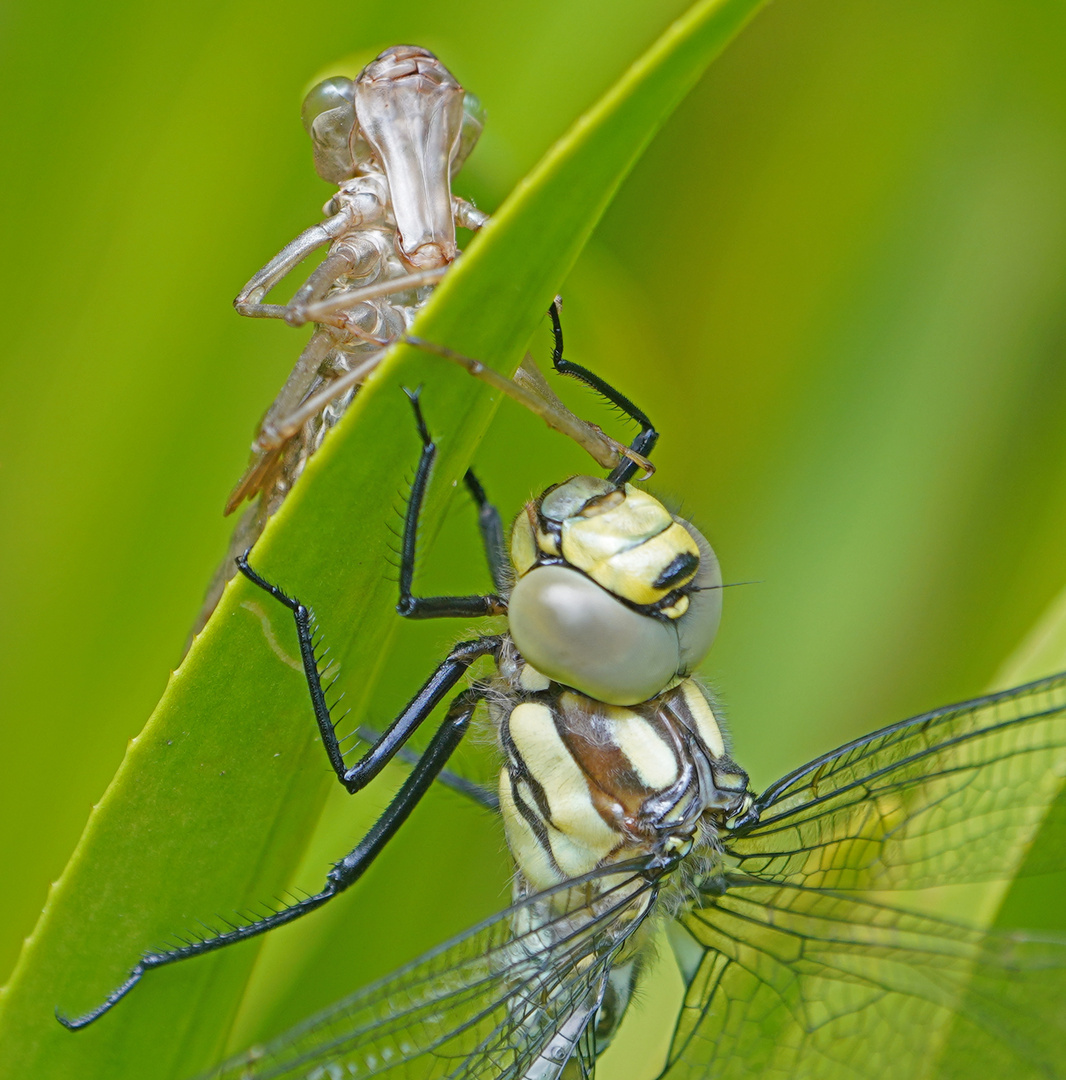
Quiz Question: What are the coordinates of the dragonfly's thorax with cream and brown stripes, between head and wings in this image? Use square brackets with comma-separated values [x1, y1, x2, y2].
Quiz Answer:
[494, 639, 748, 890]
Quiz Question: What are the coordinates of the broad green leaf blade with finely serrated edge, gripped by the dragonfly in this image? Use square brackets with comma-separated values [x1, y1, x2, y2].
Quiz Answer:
[0, 0, 760, 1080]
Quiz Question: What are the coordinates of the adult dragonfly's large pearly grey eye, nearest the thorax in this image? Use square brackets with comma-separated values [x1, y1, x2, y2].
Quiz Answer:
[508, 566, 679, 705]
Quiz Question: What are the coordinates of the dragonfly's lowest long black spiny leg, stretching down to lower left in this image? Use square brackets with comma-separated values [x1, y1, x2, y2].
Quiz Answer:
[56, 686, 485, 1030]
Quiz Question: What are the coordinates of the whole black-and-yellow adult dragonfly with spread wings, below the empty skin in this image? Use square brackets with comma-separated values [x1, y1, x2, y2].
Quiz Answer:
[60, 339, 1066, 1080]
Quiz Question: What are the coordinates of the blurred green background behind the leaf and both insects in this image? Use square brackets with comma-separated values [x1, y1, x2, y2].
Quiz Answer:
[0, 0, 1066, 1071]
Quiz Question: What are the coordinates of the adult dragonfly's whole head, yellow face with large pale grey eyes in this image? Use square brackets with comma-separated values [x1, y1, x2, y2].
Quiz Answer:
[508, 476, 721, 705]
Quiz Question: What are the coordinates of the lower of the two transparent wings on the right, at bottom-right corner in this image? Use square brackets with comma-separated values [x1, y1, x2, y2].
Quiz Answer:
[663, 879, 1066, 1080]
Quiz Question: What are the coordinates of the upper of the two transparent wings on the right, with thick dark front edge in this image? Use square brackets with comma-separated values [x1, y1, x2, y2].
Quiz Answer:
[726, 674, 1066, 890]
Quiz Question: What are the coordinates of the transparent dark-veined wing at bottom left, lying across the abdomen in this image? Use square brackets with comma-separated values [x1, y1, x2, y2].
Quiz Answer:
[197, 867, 656, 1080]
